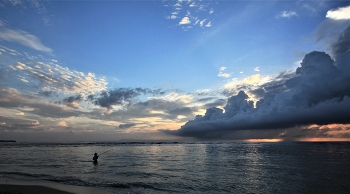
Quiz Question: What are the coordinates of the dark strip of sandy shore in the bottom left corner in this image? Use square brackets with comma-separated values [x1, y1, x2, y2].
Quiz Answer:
[0, 178, 111, 194]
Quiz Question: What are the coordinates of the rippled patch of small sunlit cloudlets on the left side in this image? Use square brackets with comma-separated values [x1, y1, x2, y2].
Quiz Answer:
[2, 55, 107, 97]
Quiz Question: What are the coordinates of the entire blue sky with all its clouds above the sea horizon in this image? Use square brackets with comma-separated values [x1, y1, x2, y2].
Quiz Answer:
[0, 0, 350, 142]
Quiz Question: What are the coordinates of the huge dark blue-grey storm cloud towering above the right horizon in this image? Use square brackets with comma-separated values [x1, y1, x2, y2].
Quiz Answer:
[164, 51, 350, 138]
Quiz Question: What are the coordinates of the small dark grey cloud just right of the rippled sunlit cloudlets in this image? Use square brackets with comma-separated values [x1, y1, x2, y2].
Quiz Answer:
[92, 88, 164, 109]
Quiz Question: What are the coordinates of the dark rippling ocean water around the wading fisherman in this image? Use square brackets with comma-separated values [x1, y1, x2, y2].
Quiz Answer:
[0, 142, 350, 193]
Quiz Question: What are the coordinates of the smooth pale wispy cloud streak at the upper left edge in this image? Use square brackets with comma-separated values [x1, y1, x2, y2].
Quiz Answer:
[0, 28, 52, 53]
